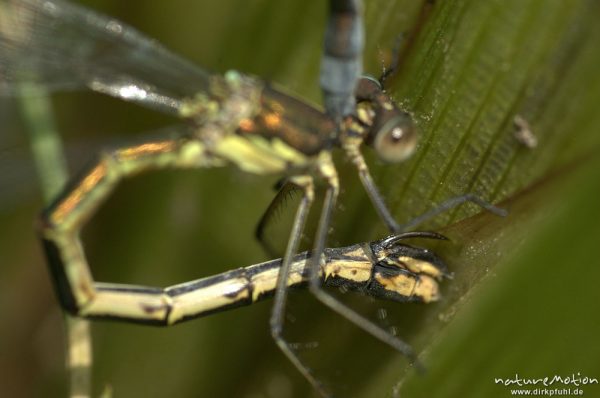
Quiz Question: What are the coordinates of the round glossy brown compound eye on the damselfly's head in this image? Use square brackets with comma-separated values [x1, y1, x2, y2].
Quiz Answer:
[373, 114, 417, 163]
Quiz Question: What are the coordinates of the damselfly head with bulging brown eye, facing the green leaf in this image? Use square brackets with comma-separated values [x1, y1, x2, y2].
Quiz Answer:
[356, 77, 417, 163]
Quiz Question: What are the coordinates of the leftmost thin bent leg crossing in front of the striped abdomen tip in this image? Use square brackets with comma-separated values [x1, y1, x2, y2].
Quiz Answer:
[270, 176, 327, 396]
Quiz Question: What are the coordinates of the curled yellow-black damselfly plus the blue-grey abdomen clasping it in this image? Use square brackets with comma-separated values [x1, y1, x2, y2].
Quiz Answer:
[0, 0, 506, 394]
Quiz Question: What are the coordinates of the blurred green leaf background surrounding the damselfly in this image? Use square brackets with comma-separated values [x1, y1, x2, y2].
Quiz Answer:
[0, 0, 600, 398]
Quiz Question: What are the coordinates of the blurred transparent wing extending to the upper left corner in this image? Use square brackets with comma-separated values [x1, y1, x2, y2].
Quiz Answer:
[0, 0, 209, 114]
